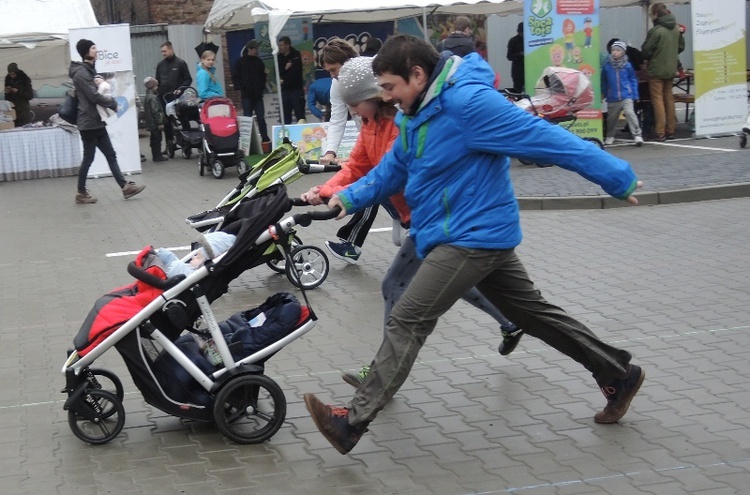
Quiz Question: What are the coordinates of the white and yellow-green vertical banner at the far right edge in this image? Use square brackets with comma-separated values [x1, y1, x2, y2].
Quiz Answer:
[691, 0, 747, 136]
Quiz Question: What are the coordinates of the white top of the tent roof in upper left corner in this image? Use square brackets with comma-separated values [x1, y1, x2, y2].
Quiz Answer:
[0, 0, 99, 46]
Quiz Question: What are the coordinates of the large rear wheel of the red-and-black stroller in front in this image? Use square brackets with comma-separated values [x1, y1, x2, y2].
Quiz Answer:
[214, 375, 286, 444]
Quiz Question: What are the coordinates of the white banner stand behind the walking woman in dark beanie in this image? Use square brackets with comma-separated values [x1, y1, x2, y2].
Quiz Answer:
[69, 24, 141, 177]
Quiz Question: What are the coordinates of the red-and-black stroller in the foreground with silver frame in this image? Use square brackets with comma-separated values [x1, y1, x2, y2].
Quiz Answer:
[62, 184, 338, 444]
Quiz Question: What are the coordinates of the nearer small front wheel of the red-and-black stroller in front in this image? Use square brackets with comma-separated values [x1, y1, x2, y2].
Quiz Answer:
[68, 388, 125, 445]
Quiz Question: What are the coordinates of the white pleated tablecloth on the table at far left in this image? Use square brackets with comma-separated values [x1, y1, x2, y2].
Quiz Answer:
[0, 127, 81, 182]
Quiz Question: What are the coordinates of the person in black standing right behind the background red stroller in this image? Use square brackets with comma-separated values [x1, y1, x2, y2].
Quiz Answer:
[232, 40, 270, 141]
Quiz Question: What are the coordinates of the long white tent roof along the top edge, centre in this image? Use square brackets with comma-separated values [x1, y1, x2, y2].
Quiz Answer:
[205, 0, 664, 33]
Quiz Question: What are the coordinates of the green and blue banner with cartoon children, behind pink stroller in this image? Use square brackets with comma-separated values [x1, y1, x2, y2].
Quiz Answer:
[523, 0, 602, 139]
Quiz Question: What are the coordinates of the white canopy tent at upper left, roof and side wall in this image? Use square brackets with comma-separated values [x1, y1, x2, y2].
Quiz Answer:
[0, 0, 99, 89]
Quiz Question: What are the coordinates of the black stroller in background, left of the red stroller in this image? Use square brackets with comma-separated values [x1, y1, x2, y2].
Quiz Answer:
[164, 87, 203, 158]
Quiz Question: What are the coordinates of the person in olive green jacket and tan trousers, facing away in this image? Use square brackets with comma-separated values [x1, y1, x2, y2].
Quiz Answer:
[641, 3, 685, 141]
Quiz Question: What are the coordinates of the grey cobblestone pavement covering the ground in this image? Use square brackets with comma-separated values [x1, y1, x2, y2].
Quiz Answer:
[0, 138, 750, 495]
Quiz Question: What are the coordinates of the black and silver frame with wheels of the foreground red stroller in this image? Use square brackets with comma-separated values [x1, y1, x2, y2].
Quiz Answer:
[62, 184, 338, 445]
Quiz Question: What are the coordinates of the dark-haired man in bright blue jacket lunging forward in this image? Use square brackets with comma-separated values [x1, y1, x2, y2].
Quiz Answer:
[305, 35, 645, 454]
